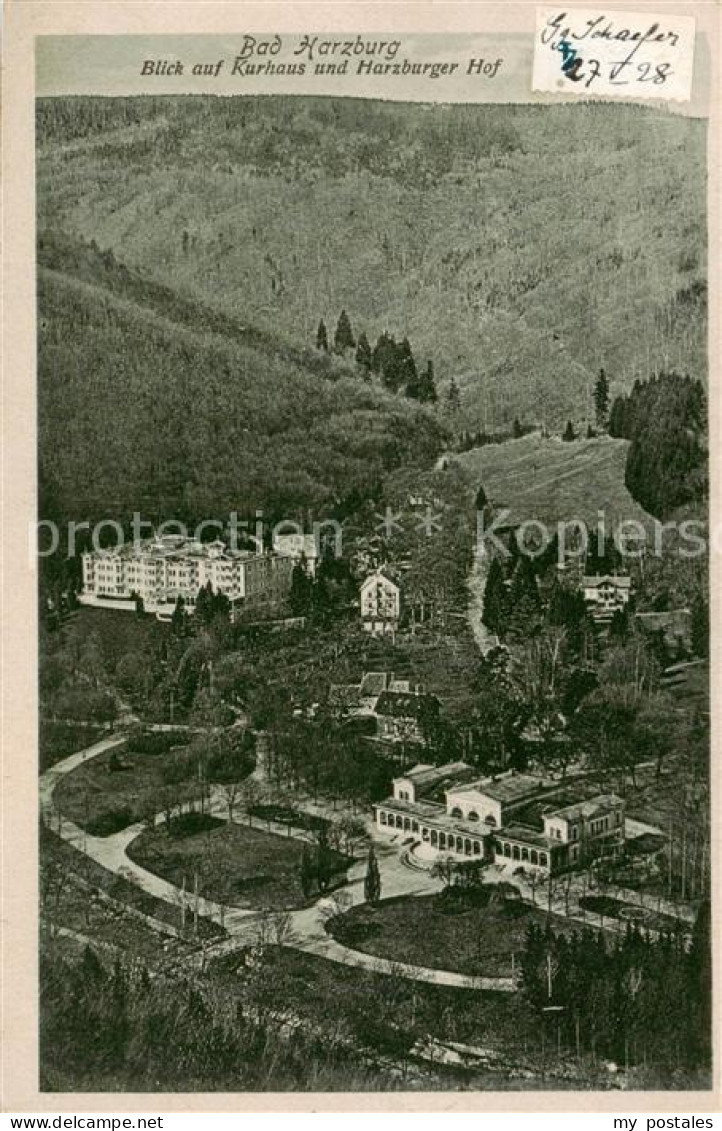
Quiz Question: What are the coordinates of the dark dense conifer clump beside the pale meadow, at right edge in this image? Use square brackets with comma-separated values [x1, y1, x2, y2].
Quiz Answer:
[609, 373, 707, 518]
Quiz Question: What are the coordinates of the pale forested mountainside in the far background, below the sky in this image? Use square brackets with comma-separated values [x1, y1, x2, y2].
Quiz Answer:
[37, 97, 706, 428]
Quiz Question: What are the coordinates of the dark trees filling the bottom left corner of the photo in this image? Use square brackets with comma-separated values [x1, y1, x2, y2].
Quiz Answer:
[41, 948, 390, 1091]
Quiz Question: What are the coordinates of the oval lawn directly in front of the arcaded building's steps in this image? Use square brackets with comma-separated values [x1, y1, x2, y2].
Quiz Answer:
[329, 892, 597, 976]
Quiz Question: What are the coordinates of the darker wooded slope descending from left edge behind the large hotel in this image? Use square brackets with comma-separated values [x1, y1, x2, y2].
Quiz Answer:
[37, 234, 442, 523]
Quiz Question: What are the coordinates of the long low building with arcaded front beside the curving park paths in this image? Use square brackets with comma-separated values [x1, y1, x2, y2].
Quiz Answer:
[375, 762, 625, 874]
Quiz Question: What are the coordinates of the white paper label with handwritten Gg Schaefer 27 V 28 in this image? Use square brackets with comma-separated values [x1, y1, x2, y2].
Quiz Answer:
[532, 7, 695, 102]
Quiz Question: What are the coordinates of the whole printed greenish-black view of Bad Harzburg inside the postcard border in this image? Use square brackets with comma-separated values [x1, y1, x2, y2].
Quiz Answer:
[0, 5, 719, 1096]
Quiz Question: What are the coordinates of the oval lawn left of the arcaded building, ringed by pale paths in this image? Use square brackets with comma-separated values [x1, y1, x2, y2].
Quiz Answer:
[128, 821, 351, 910]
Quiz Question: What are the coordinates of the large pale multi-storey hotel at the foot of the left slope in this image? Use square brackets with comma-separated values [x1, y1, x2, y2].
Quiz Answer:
[84, 535, 294, 616]
